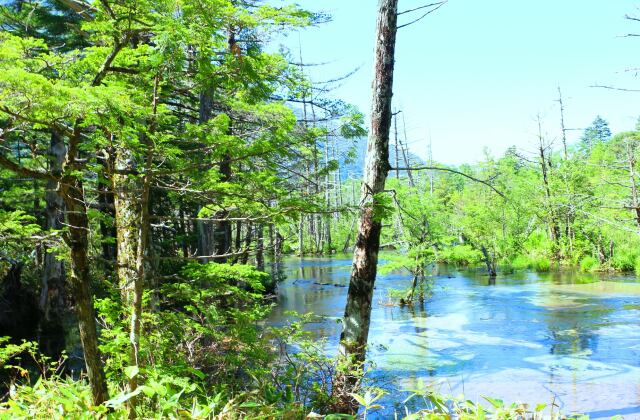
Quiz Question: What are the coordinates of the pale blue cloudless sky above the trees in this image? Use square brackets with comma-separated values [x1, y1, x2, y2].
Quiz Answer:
[271, 0, 640, 165]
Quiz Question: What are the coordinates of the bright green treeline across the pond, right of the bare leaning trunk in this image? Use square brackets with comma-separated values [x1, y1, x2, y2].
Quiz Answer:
[356, 113, 640, 284]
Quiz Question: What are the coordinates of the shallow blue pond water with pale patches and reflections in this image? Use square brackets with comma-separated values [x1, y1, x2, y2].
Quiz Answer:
[269, 257, 640, 419]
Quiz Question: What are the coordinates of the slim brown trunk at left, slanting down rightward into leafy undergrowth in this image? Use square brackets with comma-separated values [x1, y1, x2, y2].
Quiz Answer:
[59, 176, 109, 405]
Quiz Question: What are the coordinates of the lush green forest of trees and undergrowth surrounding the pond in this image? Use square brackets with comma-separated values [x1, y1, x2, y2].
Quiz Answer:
[0, 0, 640, 419]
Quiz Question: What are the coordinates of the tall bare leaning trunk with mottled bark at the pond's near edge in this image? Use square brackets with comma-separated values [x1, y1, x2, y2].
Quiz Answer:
[340, 0, 398, 382]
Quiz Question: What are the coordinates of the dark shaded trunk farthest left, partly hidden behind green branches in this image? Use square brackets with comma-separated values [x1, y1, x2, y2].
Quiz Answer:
[39, 133, 67, 358]
